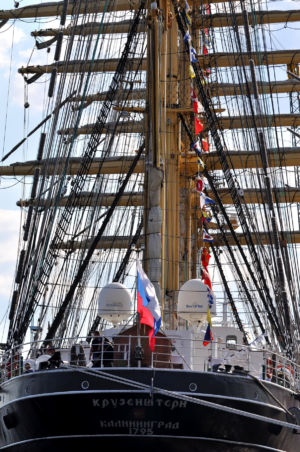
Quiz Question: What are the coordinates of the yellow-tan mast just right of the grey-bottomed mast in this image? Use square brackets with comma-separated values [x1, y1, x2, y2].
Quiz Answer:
[161, 1, 180, 328]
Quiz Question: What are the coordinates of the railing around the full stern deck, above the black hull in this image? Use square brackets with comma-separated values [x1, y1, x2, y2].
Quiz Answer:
[1, 334, 300, 390]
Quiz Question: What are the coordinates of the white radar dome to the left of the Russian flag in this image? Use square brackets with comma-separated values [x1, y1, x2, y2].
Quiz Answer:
[98, 283, 132, 325]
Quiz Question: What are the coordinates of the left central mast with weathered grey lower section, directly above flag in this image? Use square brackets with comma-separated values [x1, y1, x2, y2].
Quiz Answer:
[144, 2, 163, 308]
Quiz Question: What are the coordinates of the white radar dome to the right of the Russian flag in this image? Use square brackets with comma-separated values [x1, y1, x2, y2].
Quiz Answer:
[177, 279, 216, 323]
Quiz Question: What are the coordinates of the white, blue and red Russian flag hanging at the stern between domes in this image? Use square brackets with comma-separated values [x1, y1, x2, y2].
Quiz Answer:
[137, 261, 161, 352]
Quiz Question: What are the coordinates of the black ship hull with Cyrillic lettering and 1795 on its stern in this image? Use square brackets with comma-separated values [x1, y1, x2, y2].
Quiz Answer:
[0, 369, 300, 452]
